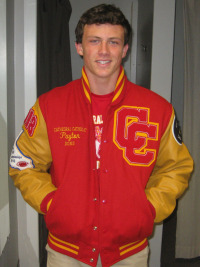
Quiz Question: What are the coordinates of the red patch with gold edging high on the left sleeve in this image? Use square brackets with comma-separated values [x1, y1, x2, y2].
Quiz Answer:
[24, 108, 38, 137]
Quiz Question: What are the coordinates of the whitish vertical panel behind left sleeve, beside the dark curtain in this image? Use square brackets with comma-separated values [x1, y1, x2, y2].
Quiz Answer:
[14, 0, 39, 267]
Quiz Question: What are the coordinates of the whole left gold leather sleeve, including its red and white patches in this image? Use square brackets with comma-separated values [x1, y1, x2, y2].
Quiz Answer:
[9, 100, 56, 213]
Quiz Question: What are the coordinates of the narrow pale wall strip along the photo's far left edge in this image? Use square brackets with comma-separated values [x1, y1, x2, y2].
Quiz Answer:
[0, 0, 10, 255]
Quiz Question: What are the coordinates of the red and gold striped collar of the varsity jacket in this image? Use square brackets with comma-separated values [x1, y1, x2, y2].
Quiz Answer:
[81, 66, 127, 104]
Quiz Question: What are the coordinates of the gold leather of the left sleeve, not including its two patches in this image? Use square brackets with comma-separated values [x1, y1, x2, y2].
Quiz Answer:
[9, 100, 56, 213]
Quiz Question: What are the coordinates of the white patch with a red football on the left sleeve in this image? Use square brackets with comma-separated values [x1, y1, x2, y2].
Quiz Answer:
[10, 131, 35, 171]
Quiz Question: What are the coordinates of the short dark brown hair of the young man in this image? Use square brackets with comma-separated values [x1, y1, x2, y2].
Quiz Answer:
[75, 4, 132, 45]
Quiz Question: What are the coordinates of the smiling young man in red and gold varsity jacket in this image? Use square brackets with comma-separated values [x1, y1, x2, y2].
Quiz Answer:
[10, 4, 193, 267]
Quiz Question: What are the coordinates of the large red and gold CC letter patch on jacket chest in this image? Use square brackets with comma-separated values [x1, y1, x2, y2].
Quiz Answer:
[113, 106, 159, 167]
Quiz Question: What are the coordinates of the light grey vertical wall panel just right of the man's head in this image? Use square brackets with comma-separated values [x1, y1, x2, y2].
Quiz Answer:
[150, 0, 175, 267]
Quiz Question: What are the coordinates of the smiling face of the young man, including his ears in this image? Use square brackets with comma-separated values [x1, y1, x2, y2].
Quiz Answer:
[76, 24, 128, 80]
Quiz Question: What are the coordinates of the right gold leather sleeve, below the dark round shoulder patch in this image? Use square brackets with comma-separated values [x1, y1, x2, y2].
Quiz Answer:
[146, 109, 193, 223]
